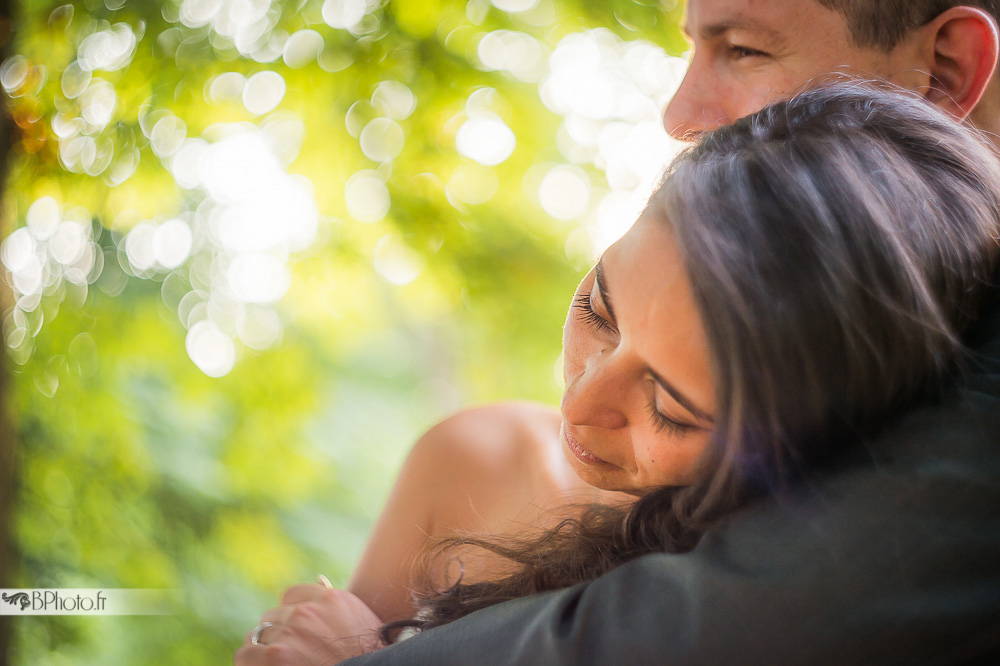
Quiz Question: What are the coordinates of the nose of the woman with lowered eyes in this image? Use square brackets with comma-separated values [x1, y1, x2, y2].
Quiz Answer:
[561, 352, 628, 430]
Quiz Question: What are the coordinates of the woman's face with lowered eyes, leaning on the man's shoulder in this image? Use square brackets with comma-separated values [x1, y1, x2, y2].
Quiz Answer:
[562, 214, 715, 495]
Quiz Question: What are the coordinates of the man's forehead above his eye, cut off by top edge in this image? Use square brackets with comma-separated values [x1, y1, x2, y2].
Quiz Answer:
[683, 0, 843, 39]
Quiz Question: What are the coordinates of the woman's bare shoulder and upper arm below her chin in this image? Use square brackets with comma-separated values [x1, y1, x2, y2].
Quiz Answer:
[347, 403, 561, 622]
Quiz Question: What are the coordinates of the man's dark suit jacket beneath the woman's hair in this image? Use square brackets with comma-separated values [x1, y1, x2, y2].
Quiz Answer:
[349, 302, 1000, 666]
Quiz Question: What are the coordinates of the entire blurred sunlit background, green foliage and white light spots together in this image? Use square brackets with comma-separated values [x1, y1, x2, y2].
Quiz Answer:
[0, 0, 686, 664]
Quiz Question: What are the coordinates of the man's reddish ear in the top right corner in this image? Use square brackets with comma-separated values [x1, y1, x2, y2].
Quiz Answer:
[922, 7, 1000, 120]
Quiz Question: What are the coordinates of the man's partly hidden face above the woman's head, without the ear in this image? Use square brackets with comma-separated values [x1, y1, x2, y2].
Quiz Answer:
[663, 0, 907, 138]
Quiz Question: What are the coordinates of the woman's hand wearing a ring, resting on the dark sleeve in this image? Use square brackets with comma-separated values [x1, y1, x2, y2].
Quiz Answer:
[233, 576, 382, 666]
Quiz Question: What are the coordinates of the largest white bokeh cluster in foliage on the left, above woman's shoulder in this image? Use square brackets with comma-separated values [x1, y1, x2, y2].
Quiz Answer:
[116, 118, 319, 377]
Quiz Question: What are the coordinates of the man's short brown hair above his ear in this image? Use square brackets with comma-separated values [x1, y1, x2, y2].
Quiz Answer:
[818, 0, 1000, 51]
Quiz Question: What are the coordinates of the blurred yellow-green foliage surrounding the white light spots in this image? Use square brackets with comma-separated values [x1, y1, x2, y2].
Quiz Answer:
[2, 0, 685, 664]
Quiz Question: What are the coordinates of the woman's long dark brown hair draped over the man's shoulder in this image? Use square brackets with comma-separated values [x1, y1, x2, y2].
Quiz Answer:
[383, 83, 1000, 641]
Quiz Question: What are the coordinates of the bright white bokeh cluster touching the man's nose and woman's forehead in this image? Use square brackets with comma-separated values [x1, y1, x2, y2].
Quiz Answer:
[538, 28, 687, 254]
